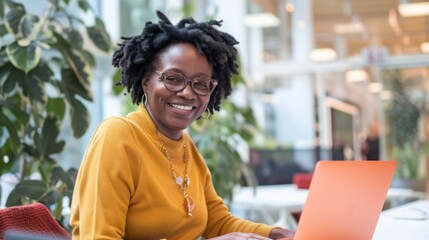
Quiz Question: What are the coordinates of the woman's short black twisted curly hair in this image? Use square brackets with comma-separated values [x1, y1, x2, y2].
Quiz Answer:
[112, 11, 238, 114]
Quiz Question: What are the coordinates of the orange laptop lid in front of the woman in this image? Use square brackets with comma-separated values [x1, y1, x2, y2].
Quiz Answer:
[294, 160, 396, 240]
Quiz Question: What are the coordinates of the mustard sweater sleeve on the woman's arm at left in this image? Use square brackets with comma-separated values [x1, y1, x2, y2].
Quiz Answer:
[70, 118, 141, 239]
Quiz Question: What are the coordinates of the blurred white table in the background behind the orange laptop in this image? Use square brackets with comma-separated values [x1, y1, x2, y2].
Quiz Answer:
[231, 184, 429, 230]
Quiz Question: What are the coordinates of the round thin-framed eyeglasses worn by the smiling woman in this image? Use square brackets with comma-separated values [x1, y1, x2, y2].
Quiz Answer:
[153, 70, 218, 96]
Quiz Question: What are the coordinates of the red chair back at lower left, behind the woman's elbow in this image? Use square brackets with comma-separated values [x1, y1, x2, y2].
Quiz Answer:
[0, 203, 71, 240]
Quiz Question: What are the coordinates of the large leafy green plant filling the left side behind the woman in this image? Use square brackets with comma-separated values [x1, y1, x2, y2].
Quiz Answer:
[0, 0, 112, 226]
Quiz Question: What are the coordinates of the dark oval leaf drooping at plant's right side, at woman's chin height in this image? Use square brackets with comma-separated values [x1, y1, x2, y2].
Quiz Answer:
[70, 99, 90, 138]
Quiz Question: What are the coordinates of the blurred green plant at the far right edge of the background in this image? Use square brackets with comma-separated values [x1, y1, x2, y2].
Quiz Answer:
[387, 70, 429, 191]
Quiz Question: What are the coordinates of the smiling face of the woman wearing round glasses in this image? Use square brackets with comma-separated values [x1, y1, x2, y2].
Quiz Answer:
[142, 43, 214, 140]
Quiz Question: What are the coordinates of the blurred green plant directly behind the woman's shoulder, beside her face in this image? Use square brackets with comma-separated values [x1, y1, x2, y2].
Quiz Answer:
[189, 59, 259, 202]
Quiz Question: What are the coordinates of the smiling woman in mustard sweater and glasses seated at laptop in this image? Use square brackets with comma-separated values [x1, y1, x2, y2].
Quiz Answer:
[70, 12, 294, 239]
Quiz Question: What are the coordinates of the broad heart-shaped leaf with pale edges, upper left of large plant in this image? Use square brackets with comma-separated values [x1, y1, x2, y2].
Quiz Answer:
[6, 41, 42, 73]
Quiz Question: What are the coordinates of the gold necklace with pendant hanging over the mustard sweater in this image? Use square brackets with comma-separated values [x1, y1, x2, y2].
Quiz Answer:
[156, 130, 195, 217]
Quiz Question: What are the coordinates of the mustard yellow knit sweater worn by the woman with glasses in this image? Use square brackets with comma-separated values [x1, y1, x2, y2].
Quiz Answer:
[70, 107, 273, 240]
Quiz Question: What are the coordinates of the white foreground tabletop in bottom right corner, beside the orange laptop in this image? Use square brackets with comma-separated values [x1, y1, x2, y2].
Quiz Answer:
[373, 200, 429, 240]
